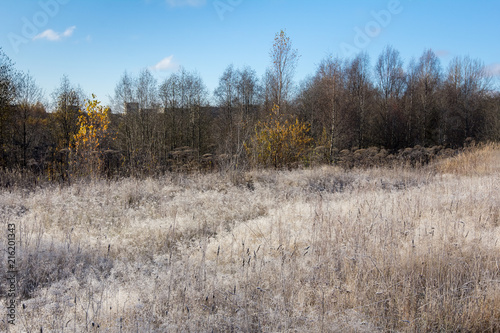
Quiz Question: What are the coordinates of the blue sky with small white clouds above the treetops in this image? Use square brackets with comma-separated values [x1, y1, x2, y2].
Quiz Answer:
[0, 0, 500, 103]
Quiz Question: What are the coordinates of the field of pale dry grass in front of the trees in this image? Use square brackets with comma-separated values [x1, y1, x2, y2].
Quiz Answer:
[0, 145, 500, 332]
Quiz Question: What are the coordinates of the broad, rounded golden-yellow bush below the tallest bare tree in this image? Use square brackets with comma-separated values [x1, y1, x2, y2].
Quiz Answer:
[245, 105, 313, 168]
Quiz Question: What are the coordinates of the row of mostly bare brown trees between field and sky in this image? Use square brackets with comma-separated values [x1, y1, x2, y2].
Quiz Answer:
[0, 31, 500, 181]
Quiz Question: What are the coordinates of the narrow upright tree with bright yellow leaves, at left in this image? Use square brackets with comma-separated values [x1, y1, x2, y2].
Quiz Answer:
[70, 94, 110, 177]
